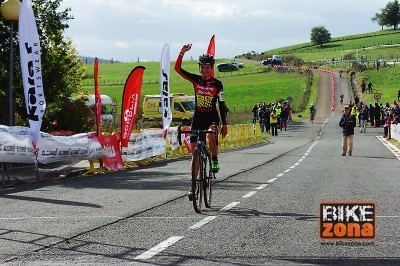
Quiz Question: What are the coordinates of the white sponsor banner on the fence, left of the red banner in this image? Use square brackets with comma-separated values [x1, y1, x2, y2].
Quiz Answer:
[0, 125, 105, 164]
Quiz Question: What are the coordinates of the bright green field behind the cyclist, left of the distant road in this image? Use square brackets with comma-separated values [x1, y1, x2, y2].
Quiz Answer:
[79, 60, 306, 121]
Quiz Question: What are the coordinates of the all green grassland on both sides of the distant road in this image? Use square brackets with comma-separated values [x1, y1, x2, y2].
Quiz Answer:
[77, 30, 400, 125]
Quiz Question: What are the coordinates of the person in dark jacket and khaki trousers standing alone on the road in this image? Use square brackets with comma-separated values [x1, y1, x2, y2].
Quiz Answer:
[339, 106, 357, 156]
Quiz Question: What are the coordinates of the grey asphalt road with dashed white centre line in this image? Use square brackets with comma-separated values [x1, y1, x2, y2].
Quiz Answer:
[0, 71, 400, 265]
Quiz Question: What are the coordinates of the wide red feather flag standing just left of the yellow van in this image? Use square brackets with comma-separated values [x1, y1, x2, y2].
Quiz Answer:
[121, 66, 146, 147]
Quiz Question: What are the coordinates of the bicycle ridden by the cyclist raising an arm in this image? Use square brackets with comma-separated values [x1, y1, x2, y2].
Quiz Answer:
[178, 126, 218, 213]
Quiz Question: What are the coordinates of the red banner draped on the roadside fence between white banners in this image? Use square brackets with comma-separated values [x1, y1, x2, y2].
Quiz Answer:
[99, 135, 124, 171]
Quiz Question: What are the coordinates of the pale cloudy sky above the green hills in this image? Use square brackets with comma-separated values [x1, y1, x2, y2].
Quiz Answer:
[60, 0, 389, 62]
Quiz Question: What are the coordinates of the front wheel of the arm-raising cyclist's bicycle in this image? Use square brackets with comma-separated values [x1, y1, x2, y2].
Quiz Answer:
[192, 148, 204, 213]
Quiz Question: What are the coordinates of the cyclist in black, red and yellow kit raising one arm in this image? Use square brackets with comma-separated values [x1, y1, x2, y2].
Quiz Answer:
[175, 44, 228, 198]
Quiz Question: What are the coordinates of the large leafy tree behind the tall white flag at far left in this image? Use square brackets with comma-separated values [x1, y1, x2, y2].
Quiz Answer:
[0, 0, 85, 128]
